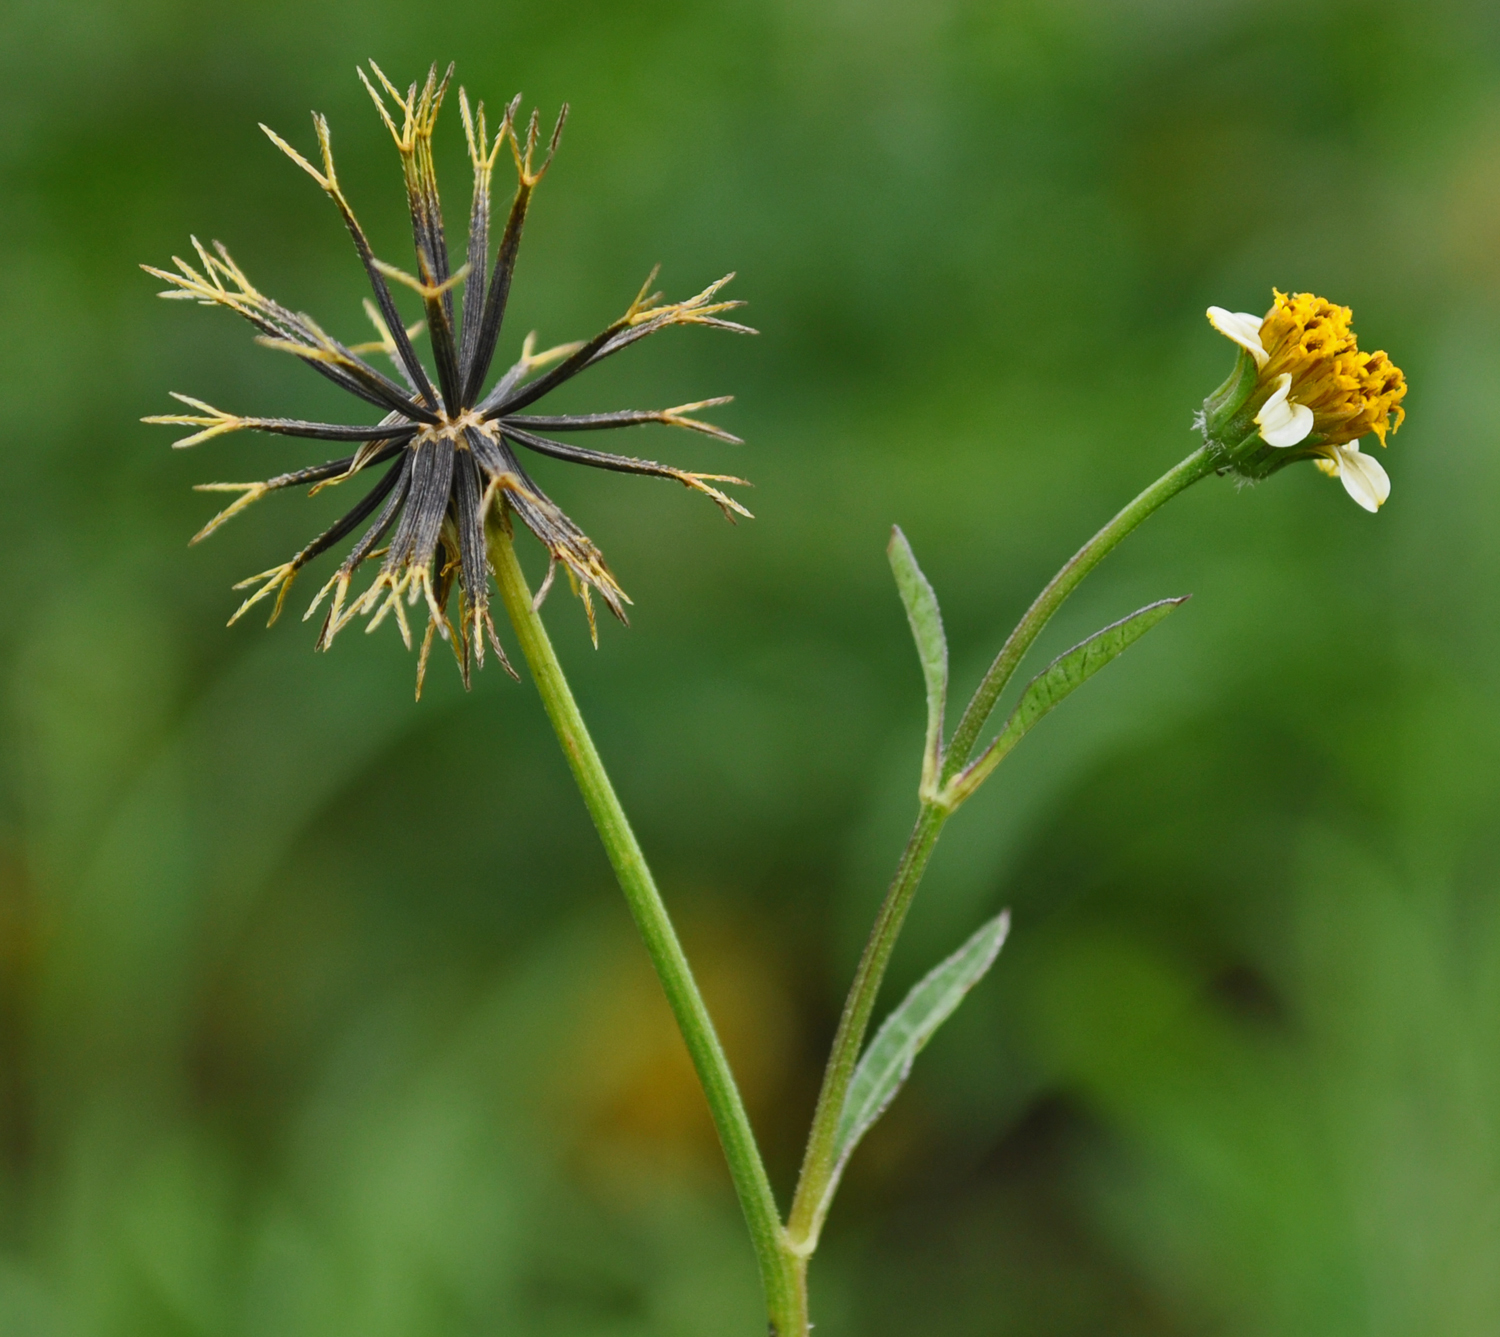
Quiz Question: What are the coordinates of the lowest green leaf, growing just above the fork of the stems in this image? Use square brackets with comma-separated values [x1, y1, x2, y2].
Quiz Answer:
[819, 911, 1011, 1220]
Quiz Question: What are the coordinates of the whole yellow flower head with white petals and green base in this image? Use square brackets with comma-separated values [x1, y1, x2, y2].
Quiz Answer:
[1202, 293, 1407, 510]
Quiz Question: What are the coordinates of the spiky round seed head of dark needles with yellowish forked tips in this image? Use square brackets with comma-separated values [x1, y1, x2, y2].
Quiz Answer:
[143, 62, 753, 696]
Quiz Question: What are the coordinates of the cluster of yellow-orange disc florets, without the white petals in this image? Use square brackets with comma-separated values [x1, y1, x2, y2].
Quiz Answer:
[1260, 290, 1406, 446]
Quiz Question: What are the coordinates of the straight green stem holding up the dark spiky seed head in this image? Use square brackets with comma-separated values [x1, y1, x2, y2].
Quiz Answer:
[489, 521, 807, 1337]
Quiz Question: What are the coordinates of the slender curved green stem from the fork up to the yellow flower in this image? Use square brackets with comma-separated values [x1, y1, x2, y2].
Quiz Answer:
[786, 447, 1214, 1257]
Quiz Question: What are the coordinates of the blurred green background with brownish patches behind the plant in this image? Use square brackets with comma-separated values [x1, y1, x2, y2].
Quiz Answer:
[0, 0, 1500, 1337]
